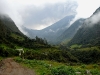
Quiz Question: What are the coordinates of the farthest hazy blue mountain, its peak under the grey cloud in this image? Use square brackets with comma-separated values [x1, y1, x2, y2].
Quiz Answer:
[24, 15, 75, 44]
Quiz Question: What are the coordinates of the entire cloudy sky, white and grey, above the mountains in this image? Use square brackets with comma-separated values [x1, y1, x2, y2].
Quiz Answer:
[0, 0, 100, 29]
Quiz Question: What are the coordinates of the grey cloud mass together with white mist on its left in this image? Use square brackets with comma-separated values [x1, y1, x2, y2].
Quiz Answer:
[0, 0, 78, 31]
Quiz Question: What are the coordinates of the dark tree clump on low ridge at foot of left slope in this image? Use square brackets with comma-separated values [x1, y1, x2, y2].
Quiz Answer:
[22, 37, 51, 49]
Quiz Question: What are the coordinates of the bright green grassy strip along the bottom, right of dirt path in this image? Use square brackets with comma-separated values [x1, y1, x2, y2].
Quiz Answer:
[15, 57, 100, 75]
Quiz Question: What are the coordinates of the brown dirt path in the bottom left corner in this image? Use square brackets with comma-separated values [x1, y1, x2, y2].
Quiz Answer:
[0, 58, 35, 75]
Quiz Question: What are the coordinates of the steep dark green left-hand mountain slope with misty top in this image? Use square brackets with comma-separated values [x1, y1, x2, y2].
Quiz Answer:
[0, 14, 25, 46]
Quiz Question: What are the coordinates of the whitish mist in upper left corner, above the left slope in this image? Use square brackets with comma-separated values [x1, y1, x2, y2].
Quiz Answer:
[0, 0, 23, 30]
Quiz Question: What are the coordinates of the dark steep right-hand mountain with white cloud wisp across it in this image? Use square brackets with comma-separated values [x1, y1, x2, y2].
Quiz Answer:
[68, 7, 100, 46]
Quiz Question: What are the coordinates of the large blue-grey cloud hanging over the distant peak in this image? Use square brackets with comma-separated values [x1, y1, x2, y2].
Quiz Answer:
[20, 2, 77, 29]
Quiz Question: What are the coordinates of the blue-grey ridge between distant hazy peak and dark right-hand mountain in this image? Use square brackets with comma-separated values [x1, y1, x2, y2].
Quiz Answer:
[58, 18, 85, 42]
